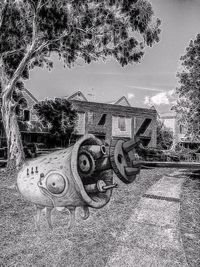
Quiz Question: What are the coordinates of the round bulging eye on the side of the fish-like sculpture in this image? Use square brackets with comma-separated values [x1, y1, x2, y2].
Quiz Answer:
[46, 173, 66, 194]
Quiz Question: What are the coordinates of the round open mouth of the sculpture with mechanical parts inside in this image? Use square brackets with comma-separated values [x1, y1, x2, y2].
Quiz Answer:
[71, 134, 113, 208]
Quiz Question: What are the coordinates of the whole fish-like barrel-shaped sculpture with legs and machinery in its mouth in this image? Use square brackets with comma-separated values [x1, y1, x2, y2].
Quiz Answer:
[17, 135, 140, 228]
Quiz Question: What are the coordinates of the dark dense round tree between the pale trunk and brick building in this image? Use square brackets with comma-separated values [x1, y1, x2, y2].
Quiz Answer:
[34, 98, 78, 146]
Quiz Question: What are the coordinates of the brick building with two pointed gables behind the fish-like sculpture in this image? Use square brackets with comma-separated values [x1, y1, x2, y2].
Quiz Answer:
[65, 91, 157, 146]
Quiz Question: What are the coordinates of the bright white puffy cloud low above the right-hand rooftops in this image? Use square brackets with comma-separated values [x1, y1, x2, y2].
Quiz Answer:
[144, 90, 174, 106]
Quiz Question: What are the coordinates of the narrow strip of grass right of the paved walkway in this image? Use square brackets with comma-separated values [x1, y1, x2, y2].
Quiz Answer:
[180, 176, 200, 267]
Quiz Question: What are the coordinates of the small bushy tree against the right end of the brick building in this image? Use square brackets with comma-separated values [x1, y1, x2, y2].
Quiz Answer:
[157, 120, 173, 149]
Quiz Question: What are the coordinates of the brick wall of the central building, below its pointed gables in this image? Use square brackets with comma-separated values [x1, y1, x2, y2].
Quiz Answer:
[71, 100, 157, 146]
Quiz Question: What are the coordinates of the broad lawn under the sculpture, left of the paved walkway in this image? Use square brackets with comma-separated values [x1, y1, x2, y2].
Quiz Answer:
[0, 169, 178, 267]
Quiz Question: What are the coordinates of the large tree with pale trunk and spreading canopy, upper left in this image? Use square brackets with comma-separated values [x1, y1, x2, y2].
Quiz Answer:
[0, 0, 160, 170]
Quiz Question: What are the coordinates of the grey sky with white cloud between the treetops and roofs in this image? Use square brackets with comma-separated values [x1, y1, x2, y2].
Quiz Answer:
[26, 0, 200, 112]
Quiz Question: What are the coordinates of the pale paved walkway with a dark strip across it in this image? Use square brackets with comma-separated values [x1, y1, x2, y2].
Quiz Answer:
[107, 172, 188, 267]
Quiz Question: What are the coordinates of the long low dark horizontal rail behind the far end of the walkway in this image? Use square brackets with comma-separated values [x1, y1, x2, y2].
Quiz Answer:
[133, 161, 200, 170]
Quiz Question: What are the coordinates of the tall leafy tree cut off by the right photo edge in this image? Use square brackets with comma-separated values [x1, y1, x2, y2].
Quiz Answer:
[173, 34, 200, 141]
